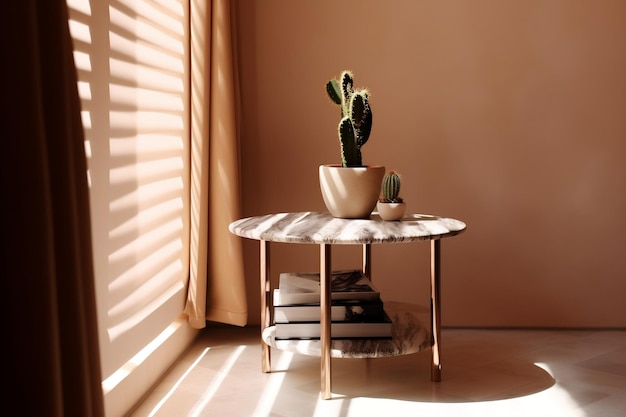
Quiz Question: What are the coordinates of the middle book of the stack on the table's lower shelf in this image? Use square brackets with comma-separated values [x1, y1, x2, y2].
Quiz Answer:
[273, 289, 384, 323]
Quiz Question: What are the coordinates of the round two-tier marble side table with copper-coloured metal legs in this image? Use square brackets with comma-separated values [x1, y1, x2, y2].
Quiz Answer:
[229, 212, 466, 399]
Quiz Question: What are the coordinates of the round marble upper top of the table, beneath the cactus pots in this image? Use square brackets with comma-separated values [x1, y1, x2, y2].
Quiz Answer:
[229, 211, 466, 244]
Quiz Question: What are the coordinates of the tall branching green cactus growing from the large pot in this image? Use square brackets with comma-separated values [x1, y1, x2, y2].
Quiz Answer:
[326, 70, 372, 167]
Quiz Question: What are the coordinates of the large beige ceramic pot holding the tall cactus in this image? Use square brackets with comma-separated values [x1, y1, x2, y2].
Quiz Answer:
[319, 165, 385, 219]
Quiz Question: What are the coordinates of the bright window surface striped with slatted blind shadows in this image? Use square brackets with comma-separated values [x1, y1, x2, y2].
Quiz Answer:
[68, 0, 189, 386]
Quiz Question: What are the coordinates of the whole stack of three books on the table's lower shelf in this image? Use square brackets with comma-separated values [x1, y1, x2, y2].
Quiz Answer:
[273, 270, 392, 339]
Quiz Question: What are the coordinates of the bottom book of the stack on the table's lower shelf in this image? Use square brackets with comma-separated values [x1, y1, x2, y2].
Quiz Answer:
[274, 312, 393, 340]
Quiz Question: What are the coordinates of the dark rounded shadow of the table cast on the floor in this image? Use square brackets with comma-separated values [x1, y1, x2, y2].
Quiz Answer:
[280, 330, 555, 403]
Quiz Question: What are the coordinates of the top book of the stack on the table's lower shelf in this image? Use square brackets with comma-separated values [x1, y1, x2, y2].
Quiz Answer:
[278, 269, 380, 304]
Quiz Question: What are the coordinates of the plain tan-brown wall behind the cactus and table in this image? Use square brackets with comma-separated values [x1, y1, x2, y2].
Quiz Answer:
[238, 0, 626, 327]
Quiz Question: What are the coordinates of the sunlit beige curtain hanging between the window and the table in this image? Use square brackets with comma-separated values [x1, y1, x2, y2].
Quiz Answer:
[185, 0, 248, 328]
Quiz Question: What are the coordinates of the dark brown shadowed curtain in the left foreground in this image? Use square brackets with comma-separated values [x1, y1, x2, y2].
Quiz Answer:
[0, 0, 104, 417]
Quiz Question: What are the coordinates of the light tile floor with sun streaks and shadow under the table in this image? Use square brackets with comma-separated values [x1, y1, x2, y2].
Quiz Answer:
[130, 326, 626, 417]
